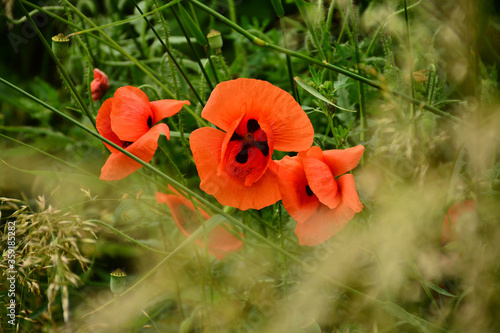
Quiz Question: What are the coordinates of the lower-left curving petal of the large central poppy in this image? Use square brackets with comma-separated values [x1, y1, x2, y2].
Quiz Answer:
[189, 127, 281, 210]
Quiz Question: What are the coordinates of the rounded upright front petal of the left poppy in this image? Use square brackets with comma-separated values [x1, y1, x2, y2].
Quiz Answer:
[111, 86, 153, 142]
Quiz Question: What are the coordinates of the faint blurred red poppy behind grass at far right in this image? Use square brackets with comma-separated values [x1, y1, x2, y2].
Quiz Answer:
[441, 200, 476, 245]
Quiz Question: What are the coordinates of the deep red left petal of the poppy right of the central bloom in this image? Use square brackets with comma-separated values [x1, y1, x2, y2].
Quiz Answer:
[278, 156, 321, 224]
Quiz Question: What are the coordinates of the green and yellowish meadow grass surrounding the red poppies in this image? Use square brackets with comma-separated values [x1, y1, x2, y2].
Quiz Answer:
[0, 0, 500, 332]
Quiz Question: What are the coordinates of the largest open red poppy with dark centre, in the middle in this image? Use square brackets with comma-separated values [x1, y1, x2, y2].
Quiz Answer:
[189, 79, 314, 210]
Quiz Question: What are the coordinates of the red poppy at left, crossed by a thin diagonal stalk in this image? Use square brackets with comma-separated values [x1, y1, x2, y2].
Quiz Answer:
[96, 86, 189, 180]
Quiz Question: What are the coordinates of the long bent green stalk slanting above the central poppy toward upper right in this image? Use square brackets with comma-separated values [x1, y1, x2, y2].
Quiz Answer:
[188, 0, 460, 122]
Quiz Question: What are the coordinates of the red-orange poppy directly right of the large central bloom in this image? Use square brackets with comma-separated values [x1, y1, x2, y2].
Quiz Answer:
[278, 145, 364, 246]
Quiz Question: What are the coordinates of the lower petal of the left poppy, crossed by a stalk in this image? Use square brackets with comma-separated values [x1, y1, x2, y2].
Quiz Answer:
[100, 123, 170, 180]
